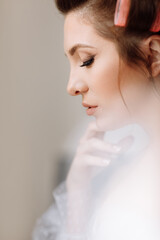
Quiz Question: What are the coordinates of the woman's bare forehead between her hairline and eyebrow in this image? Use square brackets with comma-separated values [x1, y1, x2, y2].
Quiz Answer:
[64, 12, 101, 52]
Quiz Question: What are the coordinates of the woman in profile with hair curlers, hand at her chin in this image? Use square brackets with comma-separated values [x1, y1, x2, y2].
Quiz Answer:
[33, 0, 160, 240]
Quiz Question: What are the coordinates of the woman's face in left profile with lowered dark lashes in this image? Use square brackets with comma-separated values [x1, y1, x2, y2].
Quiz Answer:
[64, 12, 151, 131]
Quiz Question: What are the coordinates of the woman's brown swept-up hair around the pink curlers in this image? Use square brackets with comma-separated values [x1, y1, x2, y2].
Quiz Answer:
[55, 0, 160, 71]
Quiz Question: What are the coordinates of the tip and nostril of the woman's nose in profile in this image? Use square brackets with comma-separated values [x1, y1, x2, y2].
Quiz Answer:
[67, 73, 88, 96]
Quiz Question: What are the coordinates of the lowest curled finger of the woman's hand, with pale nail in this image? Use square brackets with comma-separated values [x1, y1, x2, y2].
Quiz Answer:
[84, 155, 111, 167]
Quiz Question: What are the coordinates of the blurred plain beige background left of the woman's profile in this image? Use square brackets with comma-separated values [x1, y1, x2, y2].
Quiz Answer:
[0, 0, 90, 240]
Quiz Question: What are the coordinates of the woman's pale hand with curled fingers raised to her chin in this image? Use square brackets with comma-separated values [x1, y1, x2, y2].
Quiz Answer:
[67, 122, 133, 190]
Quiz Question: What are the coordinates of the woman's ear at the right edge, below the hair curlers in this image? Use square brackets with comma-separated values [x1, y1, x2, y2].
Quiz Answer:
[146, 35, 160, 77]
